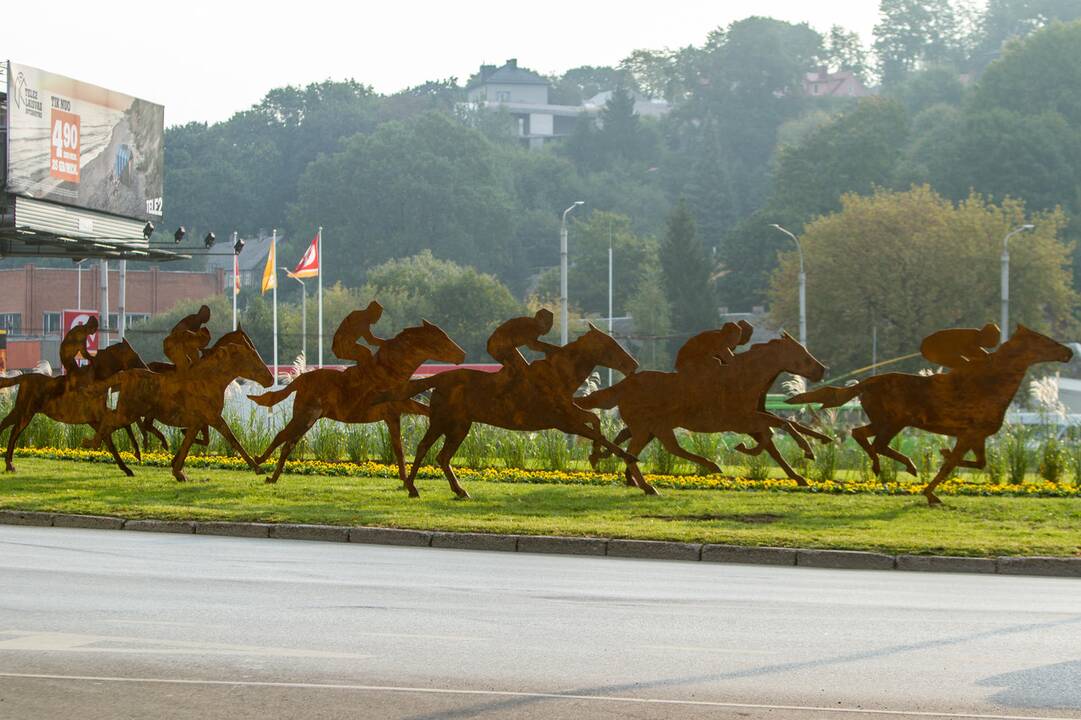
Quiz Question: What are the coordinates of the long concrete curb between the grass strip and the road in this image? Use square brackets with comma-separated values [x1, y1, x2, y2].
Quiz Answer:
[0, 510, 1081, 577]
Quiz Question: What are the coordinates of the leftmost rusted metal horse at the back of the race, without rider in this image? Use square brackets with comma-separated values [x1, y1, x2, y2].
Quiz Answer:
[0, 341, 146, 475]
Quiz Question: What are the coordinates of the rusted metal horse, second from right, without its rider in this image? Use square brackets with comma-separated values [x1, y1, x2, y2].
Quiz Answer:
[575, 333, 828, 485]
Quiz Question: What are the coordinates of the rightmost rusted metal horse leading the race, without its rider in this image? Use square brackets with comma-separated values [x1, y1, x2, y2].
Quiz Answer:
[786, 325, 1073, 505]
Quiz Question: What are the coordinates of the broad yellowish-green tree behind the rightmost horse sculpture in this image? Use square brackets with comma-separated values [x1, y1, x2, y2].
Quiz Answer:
[770, 186, 1077, 372]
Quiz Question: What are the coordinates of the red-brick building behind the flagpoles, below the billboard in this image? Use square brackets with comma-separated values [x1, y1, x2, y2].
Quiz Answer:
[0, 261, 225, 368]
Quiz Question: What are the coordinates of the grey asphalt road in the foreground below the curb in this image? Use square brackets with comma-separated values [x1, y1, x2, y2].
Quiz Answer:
[0, 525, 1081, 720]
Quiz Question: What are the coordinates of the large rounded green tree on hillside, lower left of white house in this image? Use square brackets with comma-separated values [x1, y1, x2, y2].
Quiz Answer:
[290, 112, 520, 285]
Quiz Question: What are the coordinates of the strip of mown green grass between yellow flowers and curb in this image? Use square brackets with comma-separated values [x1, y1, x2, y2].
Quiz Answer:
[0, 457, 1081, 556]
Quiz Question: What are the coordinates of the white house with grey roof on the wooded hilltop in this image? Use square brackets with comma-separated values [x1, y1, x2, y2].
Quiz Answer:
[466, 57, 668, 148]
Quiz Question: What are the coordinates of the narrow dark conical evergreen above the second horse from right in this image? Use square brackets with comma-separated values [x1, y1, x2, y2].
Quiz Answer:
[660, 200, 718, 339]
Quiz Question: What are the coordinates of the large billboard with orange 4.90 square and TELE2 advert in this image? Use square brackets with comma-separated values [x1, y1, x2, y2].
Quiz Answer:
[6, 63, 165, 221]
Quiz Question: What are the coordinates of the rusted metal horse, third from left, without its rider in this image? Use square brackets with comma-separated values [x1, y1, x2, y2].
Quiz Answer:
[250, 320, 465, 482]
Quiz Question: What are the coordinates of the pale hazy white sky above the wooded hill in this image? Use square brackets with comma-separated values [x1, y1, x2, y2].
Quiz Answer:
[0, 0, 879, 125]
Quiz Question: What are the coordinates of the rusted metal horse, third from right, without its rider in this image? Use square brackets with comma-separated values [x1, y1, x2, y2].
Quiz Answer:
[393, 324, 639, 497]
